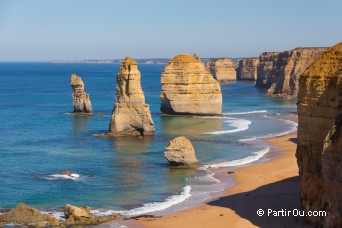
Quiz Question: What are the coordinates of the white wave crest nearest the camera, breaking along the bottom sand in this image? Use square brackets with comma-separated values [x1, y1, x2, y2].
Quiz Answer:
[91, 186, 191, 216]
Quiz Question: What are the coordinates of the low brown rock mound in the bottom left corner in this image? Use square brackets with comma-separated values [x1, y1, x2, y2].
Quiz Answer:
[0, 203, 59, 227]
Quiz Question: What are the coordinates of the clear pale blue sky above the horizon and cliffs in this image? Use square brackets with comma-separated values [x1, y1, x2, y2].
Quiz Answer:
[0, 0, 342, 61]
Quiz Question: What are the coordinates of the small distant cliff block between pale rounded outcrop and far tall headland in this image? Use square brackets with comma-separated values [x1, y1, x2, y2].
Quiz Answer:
[236, 58, 259, 81]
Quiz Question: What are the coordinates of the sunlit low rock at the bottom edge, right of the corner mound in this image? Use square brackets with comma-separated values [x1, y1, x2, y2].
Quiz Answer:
[64, 204, 118, 226]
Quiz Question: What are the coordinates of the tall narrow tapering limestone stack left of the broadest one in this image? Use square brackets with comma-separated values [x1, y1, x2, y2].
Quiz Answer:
[109, 57, 154, 136]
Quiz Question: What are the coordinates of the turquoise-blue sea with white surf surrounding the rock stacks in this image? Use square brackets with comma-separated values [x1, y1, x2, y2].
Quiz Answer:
[0, 63, 296, 215]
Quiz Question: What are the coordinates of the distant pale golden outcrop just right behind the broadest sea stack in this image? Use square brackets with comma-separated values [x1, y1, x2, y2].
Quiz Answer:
[205, 58, 236, 81]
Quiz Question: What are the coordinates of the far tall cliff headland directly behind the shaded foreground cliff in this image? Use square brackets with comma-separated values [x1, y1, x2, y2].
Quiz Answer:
[267, 48, 326, 96]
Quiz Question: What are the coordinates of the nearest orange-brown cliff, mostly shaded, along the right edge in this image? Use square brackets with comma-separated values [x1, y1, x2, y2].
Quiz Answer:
[296, 43, 342, 227]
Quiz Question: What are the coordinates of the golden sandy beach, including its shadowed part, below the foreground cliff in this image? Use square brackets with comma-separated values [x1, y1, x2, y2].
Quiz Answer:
[130, 125, 308, 228]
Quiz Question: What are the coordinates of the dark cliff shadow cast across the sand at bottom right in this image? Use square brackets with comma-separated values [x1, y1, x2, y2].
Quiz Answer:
[208, 177, 311, 228]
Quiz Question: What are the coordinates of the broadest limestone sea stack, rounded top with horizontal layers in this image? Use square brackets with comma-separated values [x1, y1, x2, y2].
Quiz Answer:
[160, 54, 222, 115]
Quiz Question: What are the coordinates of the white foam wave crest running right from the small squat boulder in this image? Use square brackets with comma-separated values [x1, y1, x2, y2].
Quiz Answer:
[204, 147, 270, 168]
